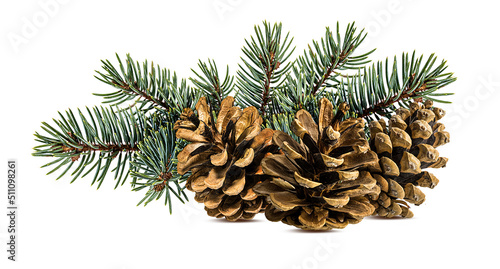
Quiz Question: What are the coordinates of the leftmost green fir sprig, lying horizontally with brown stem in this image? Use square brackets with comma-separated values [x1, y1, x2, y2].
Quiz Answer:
[33, 107, 152, 188]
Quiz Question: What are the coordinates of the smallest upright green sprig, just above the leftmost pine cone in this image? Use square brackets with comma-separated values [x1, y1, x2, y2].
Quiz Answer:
[190, 59, 234, 113]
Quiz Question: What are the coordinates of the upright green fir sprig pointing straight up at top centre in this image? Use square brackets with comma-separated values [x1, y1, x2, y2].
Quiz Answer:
[235, 22, 295, 117]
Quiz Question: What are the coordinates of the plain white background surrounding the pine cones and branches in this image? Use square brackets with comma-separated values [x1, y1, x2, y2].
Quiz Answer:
[0, 0, 500, 269]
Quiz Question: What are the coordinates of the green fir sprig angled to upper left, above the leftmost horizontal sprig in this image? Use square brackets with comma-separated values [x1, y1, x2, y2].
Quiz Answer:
[95, 54, 199, 115]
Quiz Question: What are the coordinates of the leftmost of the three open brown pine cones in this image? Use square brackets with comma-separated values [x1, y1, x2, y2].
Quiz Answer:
[174, 97, 277, 221]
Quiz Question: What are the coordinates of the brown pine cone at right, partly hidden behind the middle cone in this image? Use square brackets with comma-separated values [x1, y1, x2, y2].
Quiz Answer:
[369, 100, 450, 218]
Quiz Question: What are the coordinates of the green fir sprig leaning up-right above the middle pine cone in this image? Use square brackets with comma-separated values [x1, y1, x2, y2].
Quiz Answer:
[270, 23, 374, 124]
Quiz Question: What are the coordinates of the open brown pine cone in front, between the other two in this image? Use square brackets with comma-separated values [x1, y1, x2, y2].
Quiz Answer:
[254, 98, 380, 230]
